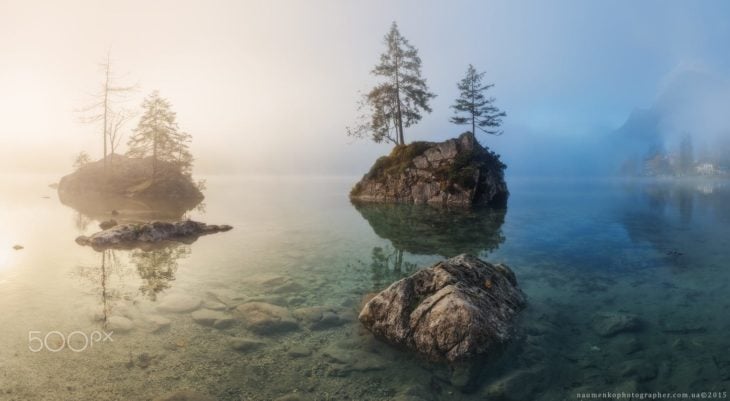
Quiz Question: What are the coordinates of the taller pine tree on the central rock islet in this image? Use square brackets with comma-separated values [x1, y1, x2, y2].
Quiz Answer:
[348, 22, 436, 145]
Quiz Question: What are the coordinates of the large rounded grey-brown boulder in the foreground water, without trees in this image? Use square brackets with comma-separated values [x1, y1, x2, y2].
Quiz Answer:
[359, 254, 526, 362]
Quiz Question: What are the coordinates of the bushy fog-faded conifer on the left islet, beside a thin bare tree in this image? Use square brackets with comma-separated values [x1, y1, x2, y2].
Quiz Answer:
[127, 91, 193, 178]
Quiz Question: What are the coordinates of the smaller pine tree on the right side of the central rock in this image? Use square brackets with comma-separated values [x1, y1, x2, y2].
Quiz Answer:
[450, 64, 507, 135]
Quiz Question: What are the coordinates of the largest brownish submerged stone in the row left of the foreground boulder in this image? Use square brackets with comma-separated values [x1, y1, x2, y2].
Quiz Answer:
[235, 302, 299, 335]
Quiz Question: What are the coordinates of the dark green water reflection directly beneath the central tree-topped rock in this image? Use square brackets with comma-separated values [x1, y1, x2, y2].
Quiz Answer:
[354, 203, 506, 288]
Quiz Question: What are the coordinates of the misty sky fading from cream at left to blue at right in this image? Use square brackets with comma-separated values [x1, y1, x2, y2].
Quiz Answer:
[0, 0, 730, 175]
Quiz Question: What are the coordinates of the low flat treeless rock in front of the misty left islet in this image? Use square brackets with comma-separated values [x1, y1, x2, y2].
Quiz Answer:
[76, 220, 232, 249]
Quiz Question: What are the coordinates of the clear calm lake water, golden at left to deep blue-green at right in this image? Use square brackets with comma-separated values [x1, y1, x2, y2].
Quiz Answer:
[0, 176, 730, 400]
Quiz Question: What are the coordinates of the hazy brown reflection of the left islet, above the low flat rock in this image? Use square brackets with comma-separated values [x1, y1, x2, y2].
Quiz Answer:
[58, 188, 205, 222]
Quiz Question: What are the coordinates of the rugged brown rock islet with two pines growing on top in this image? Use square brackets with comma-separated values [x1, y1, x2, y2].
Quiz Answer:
[350, 132, 509, 207]
